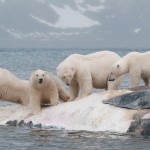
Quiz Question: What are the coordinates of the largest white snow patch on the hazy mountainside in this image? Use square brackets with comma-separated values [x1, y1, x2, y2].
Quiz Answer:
[30, 5, 100, 29]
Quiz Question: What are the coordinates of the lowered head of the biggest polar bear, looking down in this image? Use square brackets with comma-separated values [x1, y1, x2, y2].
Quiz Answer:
[57, 63, 75, 86]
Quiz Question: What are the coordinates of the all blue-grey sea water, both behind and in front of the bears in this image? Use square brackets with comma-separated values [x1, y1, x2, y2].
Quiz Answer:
[0, 49, 150, 150]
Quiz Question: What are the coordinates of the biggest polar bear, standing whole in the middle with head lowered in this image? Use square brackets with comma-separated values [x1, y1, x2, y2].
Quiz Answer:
[57, 51, 122, 100]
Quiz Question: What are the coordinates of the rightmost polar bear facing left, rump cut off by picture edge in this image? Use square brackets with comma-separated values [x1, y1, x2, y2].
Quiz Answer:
[109, 51, 150, 88]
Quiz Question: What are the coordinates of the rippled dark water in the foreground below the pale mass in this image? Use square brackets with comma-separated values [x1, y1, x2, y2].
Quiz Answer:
[0, 127, 150, 150]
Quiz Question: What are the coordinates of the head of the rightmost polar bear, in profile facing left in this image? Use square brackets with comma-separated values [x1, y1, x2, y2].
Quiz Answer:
[109, 60, 128, 81]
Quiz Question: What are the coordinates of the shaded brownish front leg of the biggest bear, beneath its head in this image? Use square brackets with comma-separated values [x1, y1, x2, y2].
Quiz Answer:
[69, 82, 79, 101]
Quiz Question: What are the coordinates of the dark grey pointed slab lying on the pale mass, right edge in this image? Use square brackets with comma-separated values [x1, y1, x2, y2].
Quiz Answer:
[103, 89, 150, 109]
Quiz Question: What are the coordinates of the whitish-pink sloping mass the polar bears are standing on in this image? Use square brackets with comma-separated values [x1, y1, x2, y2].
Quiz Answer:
[0, 90, 137, 133]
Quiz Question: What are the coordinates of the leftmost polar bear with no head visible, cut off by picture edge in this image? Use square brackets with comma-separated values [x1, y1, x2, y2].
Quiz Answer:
[0, 68, 29, 106]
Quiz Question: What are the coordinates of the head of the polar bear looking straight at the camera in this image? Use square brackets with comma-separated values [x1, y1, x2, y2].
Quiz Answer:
[30, 69, 49, 88]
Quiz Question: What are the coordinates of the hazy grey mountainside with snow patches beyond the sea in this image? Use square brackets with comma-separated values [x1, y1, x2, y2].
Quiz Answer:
[0, 0, 150, 48]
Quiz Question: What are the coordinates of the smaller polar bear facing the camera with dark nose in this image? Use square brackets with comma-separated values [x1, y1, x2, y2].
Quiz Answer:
[29, 69, 70, 114]
